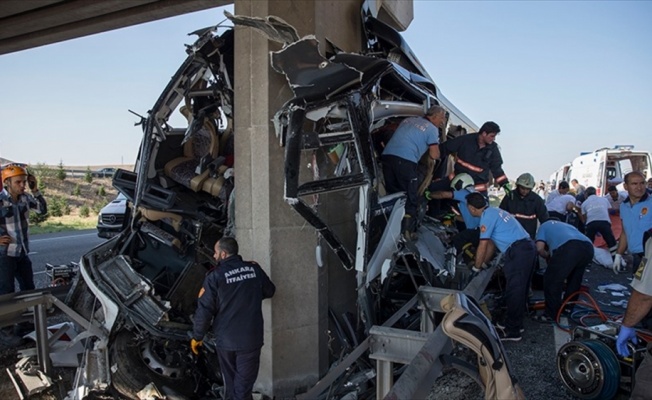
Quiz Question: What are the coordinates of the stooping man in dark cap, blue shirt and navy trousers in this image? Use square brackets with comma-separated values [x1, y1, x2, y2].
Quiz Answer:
[466, 193, 537, 342]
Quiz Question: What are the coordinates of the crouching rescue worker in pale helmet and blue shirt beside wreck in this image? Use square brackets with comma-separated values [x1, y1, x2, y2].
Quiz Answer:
[426, 173, 480, 262]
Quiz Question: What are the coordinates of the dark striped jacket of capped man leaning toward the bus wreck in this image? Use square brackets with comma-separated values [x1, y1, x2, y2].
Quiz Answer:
[439, 133, 508, 186]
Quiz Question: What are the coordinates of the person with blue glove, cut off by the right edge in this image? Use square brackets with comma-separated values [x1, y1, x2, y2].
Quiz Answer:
[616, 230, 652, 400]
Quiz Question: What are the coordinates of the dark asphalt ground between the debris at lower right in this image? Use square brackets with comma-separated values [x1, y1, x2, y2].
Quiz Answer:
[429, 264, 631, 400]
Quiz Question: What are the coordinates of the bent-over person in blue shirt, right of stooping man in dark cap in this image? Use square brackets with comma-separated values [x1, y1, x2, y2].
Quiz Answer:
[536, 220, 594, 322]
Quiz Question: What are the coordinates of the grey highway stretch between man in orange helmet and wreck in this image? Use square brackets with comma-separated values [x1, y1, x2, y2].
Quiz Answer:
[29, 229, 106, 288]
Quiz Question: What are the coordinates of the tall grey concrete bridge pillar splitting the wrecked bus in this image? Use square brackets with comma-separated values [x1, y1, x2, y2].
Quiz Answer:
[235, 0, 410, 398]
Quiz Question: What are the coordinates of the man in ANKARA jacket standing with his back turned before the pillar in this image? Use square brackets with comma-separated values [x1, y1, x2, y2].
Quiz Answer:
[190, 237, 276, 400]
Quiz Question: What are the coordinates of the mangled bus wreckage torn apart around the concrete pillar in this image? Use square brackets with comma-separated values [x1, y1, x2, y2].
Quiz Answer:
[3, 6, 522, 399]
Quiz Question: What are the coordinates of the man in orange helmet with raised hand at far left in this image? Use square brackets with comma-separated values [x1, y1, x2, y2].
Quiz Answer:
[0, 165, 48, 346]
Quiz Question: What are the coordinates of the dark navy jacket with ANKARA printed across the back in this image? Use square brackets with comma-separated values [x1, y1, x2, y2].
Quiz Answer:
[193, 255, 276, 351]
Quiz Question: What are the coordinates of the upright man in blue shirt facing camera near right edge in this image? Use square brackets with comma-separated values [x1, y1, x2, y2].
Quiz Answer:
[613, 171, 652, 273]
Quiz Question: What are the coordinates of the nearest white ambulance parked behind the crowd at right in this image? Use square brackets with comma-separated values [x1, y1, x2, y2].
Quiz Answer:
[566, 145, 652, 196]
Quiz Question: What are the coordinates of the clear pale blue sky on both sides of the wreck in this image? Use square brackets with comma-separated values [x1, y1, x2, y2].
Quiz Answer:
[0, 0, 652, 181]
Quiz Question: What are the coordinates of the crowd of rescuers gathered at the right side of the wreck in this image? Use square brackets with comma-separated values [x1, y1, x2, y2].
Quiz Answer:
[382, 106, 652, 398]
